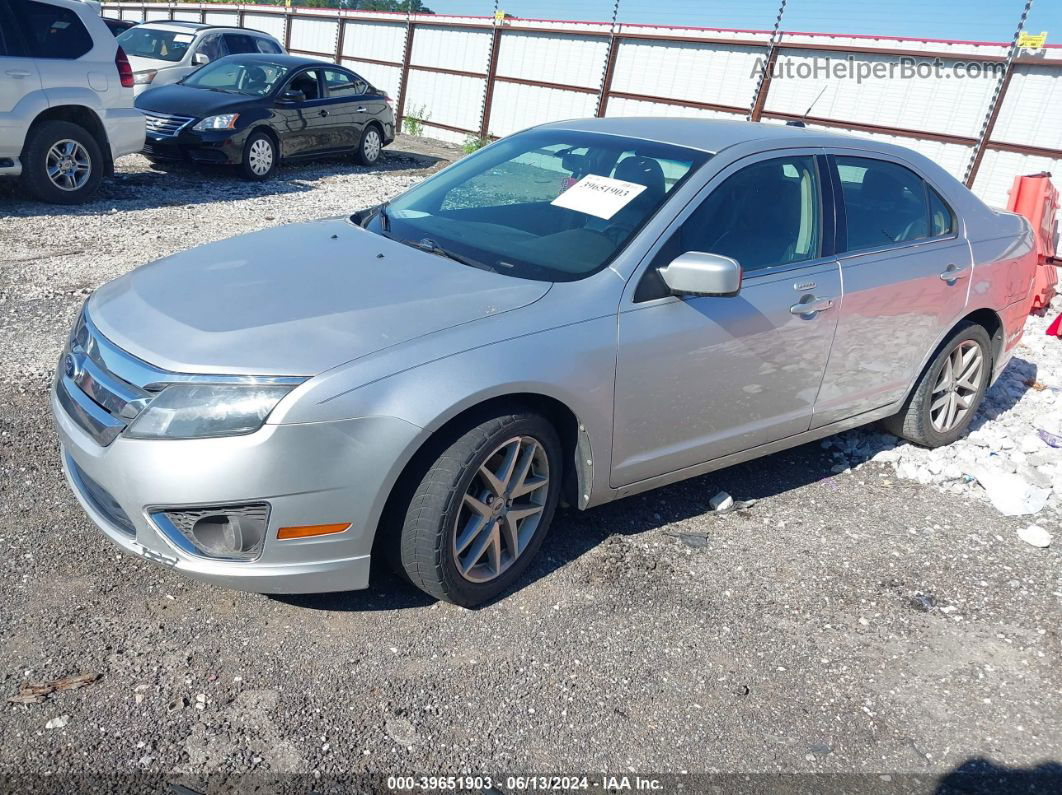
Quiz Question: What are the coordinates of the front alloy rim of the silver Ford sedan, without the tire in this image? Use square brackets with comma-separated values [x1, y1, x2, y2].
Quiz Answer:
[452, 436, 549, 583]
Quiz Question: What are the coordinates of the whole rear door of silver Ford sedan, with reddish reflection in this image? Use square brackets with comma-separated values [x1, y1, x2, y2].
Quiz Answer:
[812, 150, 972, 428]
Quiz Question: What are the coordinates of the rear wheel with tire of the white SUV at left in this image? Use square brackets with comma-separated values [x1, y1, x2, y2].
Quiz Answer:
[22, 121, 105, 204]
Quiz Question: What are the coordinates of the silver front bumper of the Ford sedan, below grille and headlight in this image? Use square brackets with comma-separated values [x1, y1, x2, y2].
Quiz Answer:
[51, 383, 419, 593]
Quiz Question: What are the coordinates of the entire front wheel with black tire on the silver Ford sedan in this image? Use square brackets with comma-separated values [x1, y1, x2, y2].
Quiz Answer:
[396, 411, 563, 607]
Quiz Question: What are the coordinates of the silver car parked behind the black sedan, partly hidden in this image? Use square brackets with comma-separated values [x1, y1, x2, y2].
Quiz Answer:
[118, 20, 285, 94]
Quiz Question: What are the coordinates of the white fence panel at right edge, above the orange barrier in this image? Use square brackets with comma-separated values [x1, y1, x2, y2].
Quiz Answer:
[992, 66, 1062, 149]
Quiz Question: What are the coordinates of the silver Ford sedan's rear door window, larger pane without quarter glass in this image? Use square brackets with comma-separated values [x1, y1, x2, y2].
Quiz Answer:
[837, 157, 929, 252]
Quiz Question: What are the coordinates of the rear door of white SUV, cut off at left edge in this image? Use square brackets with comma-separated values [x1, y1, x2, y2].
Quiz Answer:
[0, 0, 48, 161]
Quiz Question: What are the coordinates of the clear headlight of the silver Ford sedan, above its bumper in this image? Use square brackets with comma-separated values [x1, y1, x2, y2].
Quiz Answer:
[125, 383, 294, 439]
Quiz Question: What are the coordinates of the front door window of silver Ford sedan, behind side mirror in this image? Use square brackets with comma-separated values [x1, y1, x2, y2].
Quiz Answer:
[636, 155, 822, 278]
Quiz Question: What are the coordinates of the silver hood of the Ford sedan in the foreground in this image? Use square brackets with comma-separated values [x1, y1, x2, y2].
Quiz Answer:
[86, 219, 550, 376]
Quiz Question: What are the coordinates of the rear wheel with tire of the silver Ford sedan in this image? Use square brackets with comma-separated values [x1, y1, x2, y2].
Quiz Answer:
[881, 323, 993, 448]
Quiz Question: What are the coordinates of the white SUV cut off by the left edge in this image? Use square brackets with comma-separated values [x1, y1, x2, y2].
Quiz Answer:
[0, 0, 144, 204]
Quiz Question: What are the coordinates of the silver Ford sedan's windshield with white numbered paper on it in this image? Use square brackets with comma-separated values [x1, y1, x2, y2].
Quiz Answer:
[365, 129, 709, 281]
